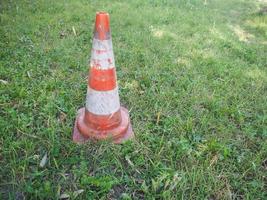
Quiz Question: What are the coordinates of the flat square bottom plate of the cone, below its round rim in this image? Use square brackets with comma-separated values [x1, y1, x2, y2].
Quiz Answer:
[72, 107, 134, 144]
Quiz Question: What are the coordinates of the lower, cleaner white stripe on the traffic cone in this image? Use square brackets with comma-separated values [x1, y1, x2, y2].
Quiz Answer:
[86, 87, 120, 115]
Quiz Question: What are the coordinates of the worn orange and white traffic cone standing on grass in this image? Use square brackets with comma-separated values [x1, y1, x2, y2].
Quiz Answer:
[73, 12, 134, 143]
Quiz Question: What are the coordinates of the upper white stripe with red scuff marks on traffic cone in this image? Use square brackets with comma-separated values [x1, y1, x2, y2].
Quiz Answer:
[90, 38, 115, 69]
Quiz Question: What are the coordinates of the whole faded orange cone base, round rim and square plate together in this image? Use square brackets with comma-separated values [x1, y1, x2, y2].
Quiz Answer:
[72, 107, 134, 144]
